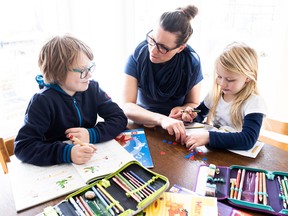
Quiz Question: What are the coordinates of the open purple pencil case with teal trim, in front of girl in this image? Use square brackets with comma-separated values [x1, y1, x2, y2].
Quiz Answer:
[194, 164, 288, 215]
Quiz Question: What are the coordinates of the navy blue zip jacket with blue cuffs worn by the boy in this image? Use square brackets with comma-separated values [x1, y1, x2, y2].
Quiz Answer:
[14, 75, 127, 166]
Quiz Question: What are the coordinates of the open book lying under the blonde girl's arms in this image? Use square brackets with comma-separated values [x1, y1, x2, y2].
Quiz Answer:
[185, 122, 265, 158]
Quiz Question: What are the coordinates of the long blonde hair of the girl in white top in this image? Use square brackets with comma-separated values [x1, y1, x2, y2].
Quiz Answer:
[207, 42, 259, 130]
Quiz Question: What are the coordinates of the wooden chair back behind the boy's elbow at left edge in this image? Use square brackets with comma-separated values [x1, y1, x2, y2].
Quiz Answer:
[0, 137, 15, 174]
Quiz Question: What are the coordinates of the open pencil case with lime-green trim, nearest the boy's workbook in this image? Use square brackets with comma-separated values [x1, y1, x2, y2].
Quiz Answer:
[45, 161, 169, 216]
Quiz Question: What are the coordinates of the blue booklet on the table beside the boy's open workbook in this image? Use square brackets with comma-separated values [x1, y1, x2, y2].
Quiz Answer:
[116, 128, 154, 168]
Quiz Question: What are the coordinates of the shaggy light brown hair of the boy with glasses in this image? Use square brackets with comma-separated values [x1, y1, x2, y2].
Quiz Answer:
[38, 35, 94, 85]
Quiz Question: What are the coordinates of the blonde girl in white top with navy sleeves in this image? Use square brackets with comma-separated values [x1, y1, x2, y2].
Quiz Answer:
[185, 42, 266, 150]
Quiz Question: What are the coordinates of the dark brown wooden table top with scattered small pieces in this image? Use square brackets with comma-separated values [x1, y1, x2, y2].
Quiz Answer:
[0, 124, 288, 216]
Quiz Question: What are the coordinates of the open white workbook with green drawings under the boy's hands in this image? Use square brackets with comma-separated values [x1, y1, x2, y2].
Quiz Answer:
[8, 140, 135, 211]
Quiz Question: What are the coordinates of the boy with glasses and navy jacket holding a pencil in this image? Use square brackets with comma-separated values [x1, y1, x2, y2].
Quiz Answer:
[15, 36, 127, 166]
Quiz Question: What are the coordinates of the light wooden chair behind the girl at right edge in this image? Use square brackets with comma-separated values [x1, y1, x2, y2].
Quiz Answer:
[259, 118, 288, 151]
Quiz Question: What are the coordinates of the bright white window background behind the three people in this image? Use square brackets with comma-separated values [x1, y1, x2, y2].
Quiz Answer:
[0, 0, 288, 137]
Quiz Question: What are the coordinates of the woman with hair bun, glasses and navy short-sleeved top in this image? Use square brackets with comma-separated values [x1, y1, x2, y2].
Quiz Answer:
[123, 5, 203, 143]
